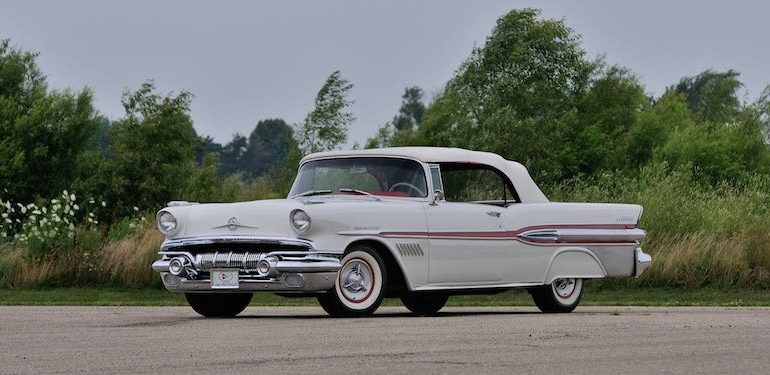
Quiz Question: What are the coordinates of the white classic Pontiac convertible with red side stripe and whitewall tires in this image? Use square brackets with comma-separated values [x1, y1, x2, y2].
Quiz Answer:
[153, 147, 652, 317]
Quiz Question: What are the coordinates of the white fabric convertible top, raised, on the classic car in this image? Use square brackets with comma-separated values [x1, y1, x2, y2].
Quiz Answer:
[300, 147, 548, 203]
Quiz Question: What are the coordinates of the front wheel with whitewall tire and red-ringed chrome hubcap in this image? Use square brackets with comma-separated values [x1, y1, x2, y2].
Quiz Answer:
[318, 245, 387, 317]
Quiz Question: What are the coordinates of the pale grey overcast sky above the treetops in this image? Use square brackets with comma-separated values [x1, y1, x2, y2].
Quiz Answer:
[0, 0, 770, 144]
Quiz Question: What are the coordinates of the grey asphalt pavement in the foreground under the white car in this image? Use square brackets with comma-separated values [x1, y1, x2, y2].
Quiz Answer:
[0, 306, 770, 375]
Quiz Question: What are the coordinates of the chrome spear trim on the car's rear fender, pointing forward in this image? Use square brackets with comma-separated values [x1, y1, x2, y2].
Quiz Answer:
[518, 228, 647, 242]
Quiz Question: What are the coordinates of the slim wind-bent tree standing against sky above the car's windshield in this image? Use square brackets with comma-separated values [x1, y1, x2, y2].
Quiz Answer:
[297, 70, 355, 154]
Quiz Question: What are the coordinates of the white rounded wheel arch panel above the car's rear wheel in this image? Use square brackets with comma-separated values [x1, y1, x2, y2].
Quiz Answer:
[543, 247, 607, 285]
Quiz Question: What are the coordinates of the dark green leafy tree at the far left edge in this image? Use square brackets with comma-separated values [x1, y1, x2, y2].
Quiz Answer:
[0, 39, 100, 203]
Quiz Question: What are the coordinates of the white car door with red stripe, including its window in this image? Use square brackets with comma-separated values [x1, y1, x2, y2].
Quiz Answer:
[425, 163, 510, 286]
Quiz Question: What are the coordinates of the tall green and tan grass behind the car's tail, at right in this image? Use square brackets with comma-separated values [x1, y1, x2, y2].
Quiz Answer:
[547, 164, 770, 288]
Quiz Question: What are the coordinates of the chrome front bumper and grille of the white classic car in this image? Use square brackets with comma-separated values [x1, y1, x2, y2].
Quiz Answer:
[152, 236, 341, 293]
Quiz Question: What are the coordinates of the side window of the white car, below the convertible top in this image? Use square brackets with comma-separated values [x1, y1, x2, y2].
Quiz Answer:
[441, 163, 516, 206]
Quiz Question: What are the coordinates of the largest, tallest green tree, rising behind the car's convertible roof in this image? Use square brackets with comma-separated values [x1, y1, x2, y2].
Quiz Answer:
[417, 9, 597, 181]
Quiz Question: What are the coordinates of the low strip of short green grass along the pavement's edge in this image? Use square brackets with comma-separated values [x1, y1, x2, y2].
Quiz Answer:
[0, 288, 770, 306]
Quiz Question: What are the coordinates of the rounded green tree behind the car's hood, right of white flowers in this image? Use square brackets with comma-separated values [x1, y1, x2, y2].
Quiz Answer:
[110, 81, 200, 216]
